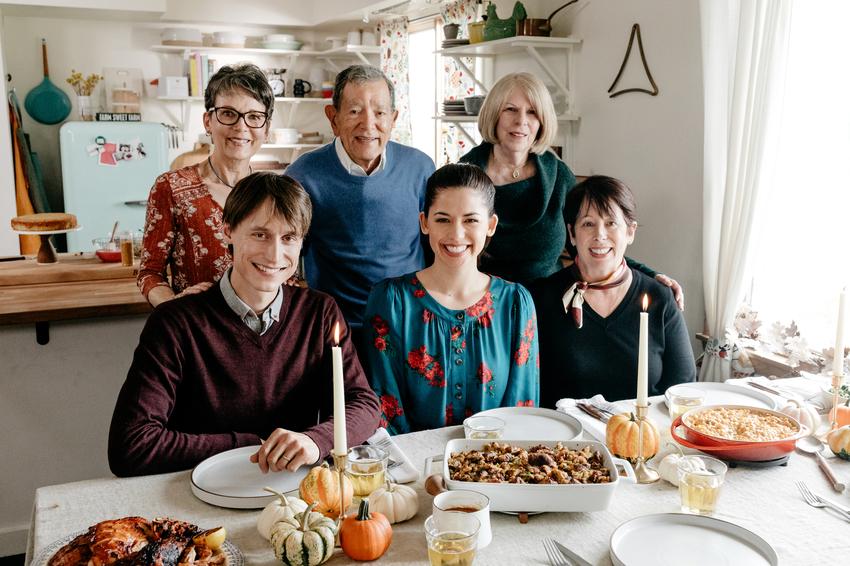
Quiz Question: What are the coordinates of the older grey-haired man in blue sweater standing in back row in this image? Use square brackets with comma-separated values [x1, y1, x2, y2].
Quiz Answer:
[286, 65, 435, 347]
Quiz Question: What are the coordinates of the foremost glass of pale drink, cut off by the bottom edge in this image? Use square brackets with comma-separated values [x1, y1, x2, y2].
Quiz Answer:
[425, 511, 481, 566]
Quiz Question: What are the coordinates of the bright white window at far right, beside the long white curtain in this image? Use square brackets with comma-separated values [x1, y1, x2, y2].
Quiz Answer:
[750, 0, 850, 351]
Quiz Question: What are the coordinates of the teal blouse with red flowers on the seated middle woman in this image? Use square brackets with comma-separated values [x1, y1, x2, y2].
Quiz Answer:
[363, 273, 540, 434]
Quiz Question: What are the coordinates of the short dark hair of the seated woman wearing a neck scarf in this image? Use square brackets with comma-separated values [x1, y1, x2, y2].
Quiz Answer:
[564, 175, 637, 257]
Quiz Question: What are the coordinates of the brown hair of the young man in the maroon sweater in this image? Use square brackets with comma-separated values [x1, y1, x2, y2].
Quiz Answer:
[222, 171, 313, 237]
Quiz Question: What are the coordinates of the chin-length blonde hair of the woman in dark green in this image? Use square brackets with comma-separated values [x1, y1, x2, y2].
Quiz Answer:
[478, 73, 558, 158]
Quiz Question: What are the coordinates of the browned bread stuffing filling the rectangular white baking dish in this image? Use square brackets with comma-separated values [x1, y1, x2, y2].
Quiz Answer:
[448, 442, 611, 484]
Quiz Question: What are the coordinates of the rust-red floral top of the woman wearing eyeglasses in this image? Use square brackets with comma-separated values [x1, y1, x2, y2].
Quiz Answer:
[137, 165, 232, 298]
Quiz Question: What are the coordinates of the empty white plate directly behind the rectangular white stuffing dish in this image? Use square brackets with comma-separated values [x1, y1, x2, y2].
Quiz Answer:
[476, 407, 583, 441]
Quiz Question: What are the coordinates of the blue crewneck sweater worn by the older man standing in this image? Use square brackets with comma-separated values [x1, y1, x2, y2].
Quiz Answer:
[286, 142, 435, 329]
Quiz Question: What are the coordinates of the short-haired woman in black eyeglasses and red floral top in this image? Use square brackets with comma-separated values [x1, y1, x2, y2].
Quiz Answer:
[138, 64, 274, 306]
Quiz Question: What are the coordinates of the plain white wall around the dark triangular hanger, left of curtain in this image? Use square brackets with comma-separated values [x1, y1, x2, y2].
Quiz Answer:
[544, 0, 704, 351]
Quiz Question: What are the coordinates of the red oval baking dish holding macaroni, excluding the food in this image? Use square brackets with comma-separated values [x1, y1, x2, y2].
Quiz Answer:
[670, 405, 809, 462]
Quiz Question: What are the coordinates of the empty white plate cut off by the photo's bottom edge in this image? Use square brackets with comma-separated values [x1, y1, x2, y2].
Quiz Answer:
[610, 513, 779, 566]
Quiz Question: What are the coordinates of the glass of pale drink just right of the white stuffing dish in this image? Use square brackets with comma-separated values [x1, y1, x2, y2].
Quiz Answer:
[677, 456, 726, 517]
